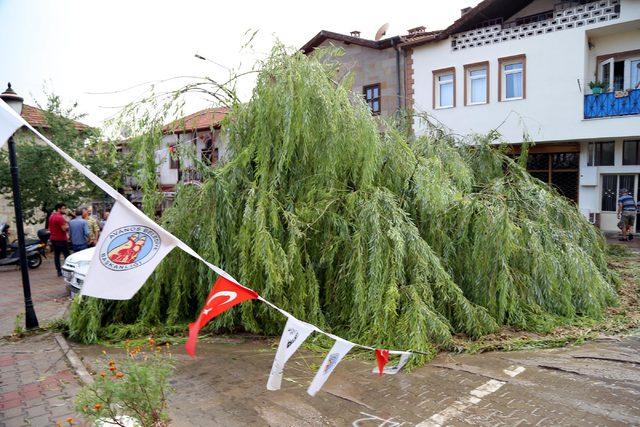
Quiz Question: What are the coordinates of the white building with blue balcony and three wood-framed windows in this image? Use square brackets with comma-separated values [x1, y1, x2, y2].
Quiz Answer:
[404, 0, 640, 234]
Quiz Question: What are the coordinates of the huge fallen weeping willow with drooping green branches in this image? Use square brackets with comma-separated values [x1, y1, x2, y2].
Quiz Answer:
[71, 47, 615, 360]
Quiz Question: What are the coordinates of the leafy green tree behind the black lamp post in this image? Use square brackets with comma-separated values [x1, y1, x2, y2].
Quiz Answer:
[0, 94, 128, 223]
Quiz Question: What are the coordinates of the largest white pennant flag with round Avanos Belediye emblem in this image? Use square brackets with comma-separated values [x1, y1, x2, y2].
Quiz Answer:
[81, 202, 177, 300]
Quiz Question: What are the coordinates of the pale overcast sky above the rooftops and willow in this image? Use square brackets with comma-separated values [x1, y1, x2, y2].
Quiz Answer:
[0, 0, 478, 125]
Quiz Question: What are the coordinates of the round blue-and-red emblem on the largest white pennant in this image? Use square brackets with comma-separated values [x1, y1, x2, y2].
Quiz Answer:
[100, 225, 162, 271]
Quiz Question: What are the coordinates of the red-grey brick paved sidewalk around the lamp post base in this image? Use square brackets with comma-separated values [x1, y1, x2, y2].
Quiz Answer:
[0, 258, 80, 427]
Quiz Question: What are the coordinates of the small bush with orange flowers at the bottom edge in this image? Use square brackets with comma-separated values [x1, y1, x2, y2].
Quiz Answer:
[76, 340, 173, 427]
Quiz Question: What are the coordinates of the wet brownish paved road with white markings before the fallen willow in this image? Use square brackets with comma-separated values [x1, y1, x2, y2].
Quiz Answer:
[77, 336, 640, 427]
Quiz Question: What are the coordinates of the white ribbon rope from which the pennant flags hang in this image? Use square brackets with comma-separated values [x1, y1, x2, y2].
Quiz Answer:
[0, 100, 416, 355]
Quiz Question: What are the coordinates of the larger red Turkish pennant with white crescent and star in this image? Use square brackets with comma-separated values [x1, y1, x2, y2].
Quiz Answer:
[184, 276, 258, 357]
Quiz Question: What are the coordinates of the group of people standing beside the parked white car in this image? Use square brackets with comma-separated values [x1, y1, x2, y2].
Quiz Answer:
[49, 203, 109, 276]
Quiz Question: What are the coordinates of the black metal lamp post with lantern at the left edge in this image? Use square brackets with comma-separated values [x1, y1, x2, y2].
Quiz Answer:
[0, 83, 38, 329]
